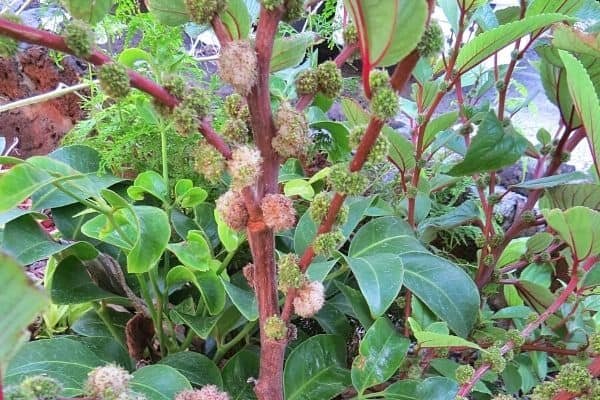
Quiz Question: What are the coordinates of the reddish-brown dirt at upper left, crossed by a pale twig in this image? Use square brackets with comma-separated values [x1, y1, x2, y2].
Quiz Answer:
[0, 46, 85, 157]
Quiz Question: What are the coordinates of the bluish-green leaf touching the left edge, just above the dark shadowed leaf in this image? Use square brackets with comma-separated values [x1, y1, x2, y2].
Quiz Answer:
[0, 214, 98, 265]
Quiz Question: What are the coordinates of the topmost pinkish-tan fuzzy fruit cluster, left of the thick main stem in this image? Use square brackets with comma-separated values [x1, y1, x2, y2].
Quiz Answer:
[219, 40, 258, 96]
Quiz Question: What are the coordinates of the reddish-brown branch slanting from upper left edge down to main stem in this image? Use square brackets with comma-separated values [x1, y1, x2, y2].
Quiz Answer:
[0, 18, 231, 158]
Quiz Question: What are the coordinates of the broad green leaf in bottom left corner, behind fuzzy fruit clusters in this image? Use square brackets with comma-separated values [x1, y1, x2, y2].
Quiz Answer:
[3, 337, 104, 397]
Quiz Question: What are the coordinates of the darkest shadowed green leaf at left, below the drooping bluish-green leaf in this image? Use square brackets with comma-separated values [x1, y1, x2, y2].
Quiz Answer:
[48, 256, 119, 304]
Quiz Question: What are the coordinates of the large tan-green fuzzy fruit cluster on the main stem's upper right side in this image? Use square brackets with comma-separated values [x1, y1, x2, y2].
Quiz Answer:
[271, 103, 311, 158]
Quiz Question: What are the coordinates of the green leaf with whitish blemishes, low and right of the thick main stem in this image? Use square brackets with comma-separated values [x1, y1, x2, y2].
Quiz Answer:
[351, 318, 410, 394]
